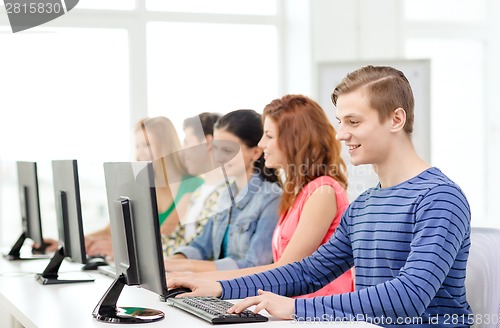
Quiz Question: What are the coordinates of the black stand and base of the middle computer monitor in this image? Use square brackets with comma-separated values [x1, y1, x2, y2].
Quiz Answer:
[36, 247, 95, 285]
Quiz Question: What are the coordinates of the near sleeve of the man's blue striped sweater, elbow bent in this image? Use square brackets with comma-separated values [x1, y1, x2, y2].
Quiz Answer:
[295, 184, 470, 320]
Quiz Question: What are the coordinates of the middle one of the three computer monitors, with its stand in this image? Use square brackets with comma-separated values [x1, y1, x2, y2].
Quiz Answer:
[36, 160, 94, 285]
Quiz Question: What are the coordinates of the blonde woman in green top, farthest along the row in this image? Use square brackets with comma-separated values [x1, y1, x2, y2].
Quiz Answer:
[85, 116, 203, 256]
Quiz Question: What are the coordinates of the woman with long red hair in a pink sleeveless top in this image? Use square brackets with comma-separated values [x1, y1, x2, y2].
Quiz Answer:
[170, 95, 353, 297]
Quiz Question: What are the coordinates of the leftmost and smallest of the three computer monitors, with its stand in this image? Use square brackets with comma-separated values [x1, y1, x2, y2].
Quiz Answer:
[5, 161, 49, 260]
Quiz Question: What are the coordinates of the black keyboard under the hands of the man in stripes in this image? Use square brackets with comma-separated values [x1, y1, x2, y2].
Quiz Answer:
[167, 297, 268, 324]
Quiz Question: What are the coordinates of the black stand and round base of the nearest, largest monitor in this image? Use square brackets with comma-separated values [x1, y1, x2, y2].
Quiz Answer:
[92, 274, 165, 323]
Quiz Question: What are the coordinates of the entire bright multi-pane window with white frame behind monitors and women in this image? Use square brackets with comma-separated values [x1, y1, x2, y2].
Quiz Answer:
[0, 5, 282, 246]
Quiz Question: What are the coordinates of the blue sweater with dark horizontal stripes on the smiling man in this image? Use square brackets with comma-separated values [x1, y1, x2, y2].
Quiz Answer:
[221, 168, 472, 327]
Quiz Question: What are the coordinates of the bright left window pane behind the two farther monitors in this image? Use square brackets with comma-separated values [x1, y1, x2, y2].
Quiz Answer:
[0, 28, 132, 242]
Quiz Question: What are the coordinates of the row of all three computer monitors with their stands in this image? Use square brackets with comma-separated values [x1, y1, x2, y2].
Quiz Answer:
[6, 160, 167, 323]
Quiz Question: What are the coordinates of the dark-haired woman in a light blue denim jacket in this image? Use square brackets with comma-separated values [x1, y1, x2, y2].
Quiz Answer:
[165, 110, 281, 272]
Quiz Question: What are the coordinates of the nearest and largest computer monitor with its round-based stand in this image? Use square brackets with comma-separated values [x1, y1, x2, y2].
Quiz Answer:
[92, 162, 167, 323]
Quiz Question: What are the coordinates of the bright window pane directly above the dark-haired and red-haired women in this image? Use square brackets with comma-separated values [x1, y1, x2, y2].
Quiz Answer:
[147, 23, 278, 127]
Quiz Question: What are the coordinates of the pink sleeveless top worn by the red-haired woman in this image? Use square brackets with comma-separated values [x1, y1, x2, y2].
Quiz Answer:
[273, 176, 354, 298]
